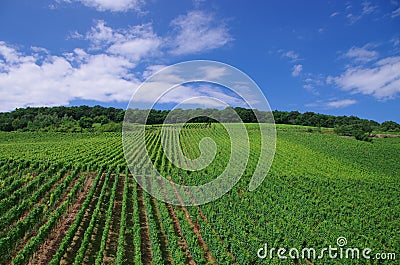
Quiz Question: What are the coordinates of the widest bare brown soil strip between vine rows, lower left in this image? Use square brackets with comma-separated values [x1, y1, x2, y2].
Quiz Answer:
[28, 174, 95, 265]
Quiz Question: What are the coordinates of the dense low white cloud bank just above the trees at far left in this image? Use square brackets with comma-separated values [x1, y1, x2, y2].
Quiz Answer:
[0, 42, 139, 111]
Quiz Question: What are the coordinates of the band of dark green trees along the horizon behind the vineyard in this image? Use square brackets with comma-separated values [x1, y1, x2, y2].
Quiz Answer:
[0, 106, 400, 135]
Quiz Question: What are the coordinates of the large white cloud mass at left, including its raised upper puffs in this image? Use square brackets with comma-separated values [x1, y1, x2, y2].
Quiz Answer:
[0, 21, 166, 111]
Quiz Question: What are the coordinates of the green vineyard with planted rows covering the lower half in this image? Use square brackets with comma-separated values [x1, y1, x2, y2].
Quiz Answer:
[0, 123, 400, 264]
